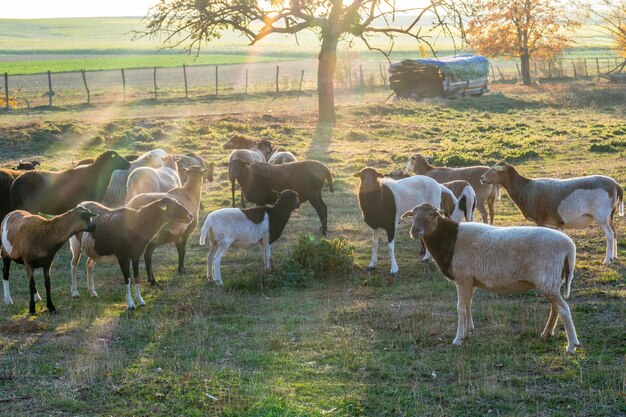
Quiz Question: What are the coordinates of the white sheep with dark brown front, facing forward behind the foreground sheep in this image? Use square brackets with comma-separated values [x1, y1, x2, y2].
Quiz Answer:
[354, 167, 460, 282]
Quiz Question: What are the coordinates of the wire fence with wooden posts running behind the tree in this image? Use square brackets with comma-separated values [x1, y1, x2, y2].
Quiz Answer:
[0, 57, 624, 109]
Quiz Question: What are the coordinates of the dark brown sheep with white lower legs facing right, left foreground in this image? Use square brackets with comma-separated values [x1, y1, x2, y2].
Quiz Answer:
[70, 197, 193, 310]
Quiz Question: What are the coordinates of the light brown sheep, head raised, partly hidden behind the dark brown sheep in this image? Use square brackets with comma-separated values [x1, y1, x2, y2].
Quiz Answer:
[126, 165, 206, 285]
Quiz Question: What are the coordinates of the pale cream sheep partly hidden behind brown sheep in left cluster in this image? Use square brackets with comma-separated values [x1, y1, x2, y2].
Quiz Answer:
[126, 155, 181, 201]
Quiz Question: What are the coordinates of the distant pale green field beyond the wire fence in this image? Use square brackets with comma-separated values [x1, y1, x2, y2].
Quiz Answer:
[0, 16, 615, 75]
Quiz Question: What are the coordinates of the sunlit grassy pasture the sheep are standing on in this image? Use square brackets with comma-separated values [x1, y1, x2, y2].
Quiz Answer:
[0, 84, 626, 417]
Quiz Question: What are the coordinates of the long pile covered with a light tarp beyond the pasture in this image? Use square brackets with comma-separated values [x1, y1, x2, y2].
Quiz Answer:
[389, 55, 489, 98]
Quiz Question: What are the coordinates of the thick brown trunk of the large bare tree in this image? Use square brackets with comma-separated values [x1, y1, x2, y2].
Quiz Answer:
[317, 34, 339, 125]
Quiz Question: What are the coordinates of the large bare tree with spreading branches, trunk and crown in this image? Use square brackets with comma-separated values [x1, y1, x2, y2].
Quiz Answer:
[142, 0, 462, 124]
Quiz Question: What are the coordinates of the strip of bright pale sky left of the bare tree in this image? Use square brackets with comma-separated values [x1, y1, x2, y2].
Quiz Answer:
[0, 0, 158, 19]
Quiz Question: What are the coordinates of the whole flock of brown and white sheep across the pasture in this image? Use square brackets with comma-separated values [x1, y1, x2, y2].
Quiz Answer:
[0, 136, 623, 352]
